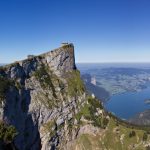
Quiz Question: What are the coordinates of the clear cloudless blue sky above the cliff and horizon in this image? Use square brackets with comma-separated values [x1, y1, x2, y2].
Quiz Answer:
[0, 0, 150, 63]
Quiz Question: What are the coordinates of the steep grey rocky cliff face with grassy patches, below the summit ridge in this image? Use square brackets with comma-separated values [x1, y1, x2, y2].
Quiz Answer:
[0, 44, 85, 150]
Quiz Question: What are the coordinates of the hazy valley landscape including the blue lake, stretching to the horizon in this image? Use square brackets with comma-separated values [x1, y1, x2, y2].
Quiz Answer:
[78, 63, 150, 125]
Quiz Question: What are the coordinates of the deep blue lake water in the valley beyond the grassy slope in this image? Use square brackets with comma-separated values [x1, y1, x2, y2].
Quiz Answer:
[105, 87, 150, 119]
